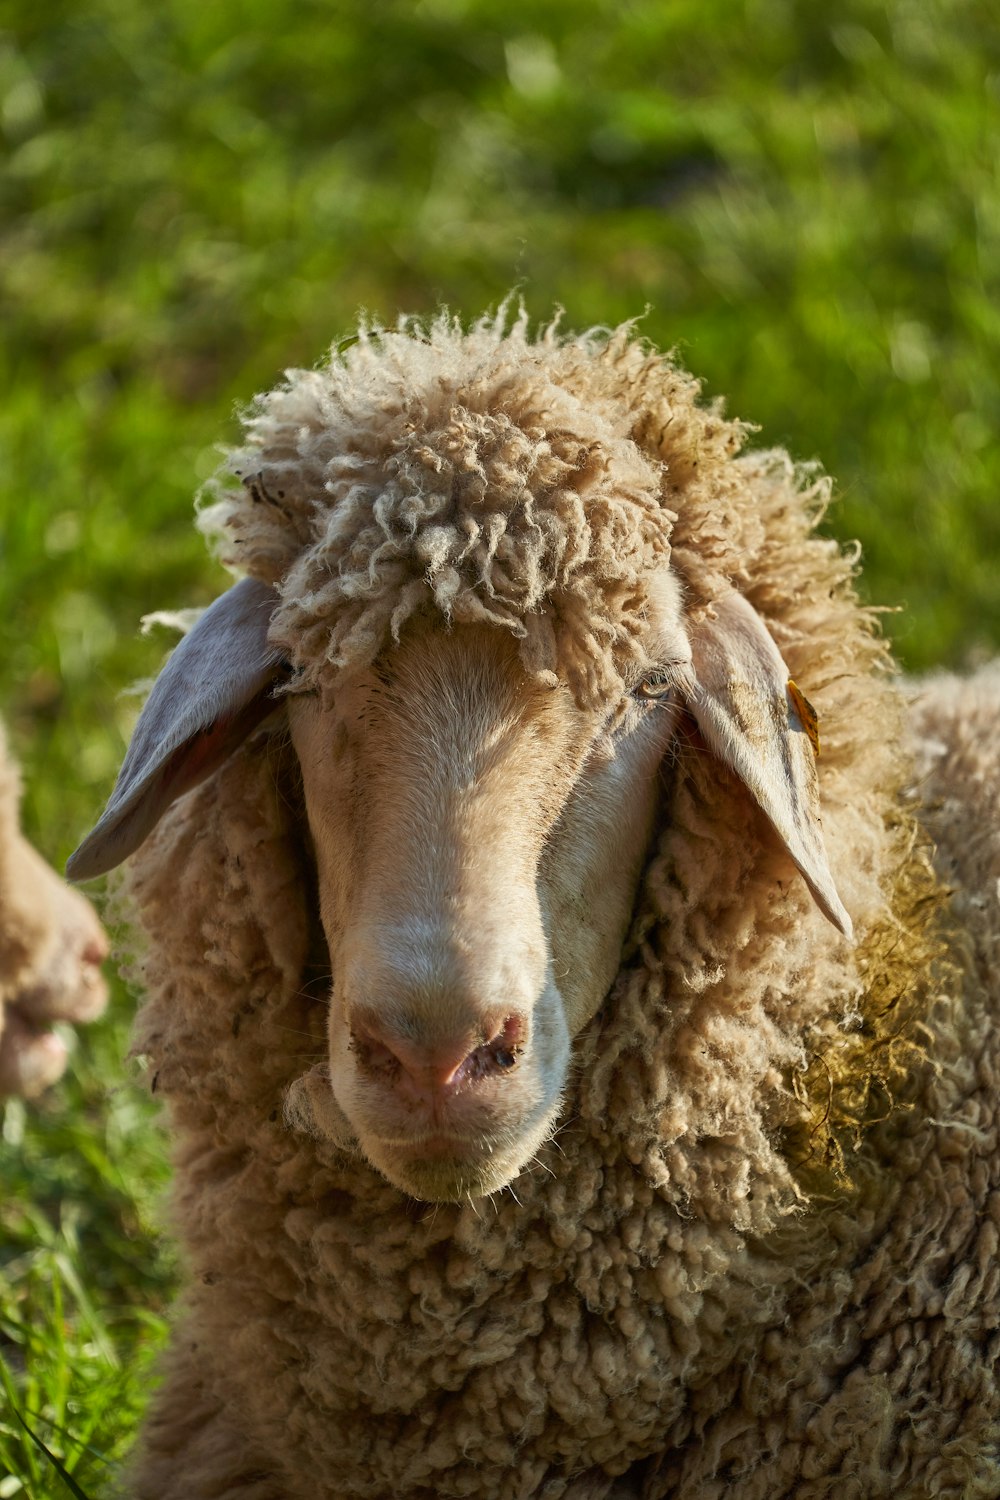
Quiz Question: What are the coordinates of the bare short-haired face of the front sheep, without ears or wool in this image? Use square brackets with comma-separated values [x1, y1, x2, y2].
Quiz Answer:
[289, 591, 682, 1200]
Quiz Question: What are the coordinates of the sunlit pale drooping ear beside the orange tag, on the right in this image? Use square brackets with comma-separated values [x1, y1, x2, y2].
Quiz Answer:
[688, 590, 853, 938]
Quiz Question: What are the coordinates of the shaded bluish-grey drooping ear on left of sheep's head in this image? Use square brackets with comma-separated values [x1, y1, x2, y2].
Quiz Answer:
[66, 578, 285, 881]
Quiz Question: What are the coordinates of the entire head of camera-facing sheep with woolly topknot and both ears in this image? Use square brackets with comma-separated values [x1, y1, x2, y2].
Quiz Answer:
[70, 312, 850, 1199]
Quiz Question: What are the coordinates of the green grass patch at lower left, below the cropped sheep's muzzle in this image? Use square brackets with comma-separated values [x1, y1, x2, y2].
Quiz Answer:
[0, 995, 174, 1500]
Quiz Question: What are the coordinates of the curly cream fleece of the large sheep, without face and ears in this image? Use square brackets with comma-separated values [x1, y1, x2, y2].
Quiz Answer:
[121, 315, 1000, 1500]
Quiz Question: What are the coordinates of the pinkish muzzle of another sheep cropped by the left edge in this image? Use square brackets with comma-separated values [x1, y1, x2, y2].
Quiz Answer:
[0, 729, 108, 1100]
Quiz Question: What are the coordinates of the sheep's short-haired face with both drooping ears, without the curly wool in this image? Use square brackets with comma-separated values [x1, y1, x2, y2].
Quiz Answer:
[70, 570, 850, 1200]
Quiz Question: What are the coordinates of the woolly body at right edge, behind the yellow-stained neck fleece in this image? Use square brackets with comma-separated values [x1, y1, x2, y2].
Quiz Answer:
[642, 663, 1000, 1500]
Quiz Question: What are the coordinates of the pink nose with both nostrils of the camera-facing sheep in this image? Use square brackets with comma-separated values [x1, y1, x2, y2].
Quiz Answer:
[351, 1013, 528, 1097]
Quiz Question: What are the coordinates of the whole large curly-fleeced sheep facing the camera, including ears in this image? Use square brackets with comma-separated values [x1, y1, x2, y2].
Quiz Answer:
[69, 314, 1000, 1500]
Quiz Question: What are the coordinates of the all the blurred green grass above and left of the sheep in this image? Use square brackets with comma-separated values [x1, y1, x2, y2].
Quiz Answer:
[0, 0, 1000, 1500]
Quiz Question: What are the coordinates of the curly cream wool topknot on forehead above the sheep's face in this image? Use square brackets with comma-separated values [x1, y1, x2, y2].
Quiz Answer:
[201, 309, 742, 701]
